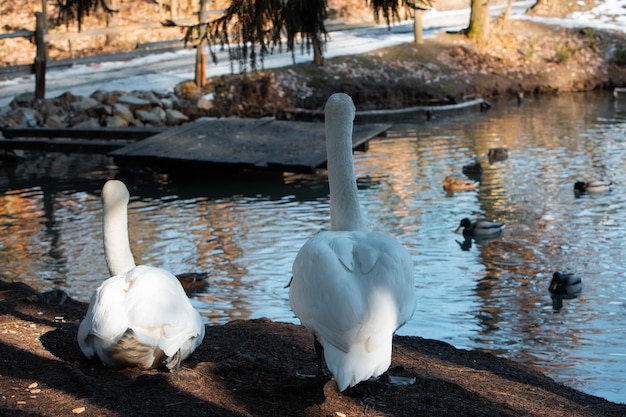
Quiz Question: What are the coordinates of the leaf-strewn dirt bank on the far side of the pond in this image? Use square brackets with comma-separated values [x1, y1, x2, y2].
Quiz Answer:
[183, 18, 626, 119]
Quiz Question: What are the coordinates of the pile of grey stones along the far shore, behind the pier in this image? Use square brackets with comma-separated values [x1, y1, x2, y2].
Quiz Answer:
[0, 90, 189, 132]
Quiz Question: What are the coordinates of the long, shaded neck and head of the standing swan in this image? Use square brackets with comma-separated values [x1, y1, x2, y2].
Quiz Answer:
[325, 94, 365, 231]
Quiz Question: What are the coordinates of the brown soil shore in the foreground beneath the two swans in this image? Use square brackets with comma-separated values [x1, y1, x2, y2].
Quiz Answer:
[0, 281, 626, 417]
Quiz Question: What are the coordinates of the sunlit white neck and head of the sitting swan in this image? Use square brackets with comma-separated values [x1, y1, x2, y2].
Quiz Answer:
[102, 180, 135, 276]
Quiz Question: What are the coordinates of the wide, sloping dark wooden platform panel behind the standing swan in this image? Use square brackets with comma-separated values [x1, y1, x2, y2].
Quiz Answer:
[109, 118, 390, 175]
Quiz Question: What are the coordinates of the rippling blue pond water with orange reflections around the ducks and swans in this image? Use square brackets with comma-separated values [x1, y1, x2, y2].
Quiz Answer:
[0, 94, 626, 402]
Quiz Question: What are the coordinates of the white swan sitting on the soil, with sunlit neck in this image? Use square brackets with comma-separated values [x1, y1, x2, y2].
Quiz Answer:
[78, 180, 204, 370]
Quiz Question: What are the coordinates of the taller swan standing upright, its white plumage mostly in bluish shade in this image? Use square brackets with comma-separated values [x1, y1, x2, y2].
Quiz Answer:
[289, 94, 416, 391]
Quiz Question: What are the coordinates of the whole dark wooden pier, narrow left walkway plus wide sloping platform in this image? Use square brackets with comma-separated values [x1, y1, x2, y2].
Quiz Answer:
[0, 118, 391, 175]
